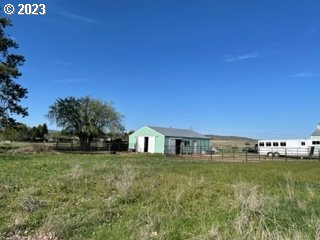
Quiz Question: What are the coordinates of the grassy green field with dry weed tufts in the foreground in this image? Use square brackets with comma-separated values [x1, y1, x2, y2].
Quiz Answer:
[0, 153, 320, 239]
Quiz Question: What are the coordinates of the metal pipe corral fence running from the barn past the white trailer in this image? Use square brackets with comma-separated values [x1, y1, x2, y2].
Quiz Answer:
[165, 146, 320, 162]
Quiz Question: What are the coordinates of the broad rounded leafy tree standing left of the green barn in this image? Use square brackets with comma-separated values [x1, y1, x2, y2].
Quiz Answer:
[47, 96, 124, 146]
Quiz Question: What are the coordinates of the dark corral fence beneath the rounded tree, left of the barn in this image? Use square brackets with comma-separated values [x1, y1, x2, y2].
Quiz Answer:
[55, 141, 128, 153]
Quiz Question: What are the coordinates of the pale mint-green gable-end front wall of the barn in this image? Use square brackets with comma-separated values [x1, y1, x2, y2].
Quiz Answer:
[129, 126, 164, 153]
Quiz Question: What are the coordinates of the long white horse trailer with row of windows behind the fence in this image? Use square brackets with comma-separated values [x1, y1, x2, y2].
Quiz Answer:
[258, 139, 320, 157]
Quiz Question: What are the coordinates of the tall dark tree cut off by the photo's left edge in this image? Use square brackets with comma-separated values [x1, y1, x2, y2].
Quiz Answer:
[0, 17, 28, 127]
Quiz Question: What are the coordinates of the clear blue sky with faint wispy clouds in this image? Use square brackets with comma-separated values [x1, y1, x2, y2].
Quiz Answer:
[2, 0, 320, 139]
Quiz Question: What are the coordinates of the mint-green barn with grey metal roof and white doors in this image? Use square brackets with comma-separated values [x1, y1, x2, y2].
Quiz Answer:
[129, 126, 210, 154]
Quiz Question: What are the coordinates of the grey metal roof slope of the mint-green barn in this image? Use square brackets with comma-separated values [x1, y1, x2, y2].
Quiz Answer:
[148, 126, 210, 139]
